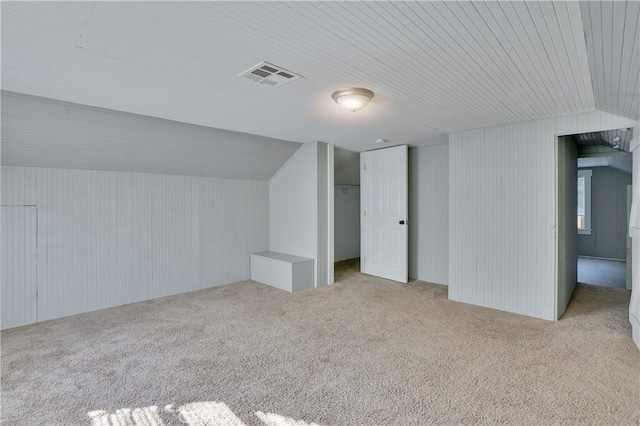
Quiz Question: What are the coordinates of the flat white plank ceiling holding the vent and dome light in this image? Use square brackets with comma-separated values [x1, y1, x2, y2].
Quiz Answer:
[2, 2, 608, 151]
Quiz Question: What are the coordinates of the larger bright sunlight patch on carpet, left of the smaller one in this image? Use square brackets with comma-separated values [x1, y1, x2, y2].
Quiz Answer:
[87, 401, 244, 426]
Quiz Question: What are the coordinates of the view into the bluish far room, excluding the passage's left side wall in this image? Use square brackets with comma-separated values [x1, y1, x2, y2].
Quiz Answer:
[572, 129, 633, 290]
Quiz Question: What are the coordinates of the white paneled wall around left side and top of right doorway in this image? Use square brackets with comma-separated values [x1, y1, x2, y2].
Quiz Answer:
[449, 112, 634, 320]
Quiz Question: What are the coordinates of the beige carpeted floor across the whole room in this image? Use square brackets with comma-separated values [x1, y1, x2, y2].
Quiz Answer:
[2, 264, 640, 426]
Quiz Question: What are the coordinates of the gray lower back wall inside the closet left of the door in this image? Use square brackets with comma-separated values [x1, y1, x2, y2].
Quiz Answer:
[334, 185, 360, 262]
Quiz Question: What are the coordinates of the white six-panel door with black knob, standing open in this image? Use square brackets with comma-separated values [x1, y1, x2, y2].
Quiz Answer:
[360, 145, 408, 283]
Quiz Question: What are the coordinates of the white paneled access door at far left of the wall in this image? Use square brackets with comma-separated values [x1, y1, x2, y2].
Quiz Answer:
[0, 206, 37, 329]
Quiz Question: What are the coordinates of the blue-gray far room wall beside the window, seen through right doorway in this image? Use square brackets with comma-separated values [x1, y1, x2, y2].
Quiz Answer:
[578, 167, 632, 260]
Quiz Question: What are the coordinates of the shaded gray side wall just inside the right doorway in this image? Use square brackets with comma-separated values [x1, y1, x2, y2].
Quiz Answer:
[556, 136, 578, 318]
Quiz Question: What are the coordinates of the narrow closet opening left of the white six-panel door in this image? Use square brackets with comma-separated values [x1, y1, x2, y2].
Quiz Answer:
[333, 147, 360, 282]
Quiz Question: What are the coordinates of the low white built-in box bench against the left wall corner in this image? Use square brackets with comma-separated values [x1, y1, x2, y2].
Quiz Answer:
[251, 251, 313, 292]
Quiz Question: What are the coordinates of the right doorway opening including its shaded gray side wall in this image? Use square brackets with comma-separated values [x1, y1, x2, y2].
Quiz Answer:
[557, 128, 633, 317]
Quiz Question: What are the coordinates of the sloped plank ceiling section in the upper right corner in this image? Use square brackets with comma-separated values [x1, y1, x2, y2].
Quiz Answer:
[580, 1, 640, 120]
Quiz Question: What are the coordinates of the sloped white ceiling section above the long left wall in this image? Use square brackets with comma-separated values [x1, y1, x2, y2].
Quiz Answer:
[1, 91, 301, 180]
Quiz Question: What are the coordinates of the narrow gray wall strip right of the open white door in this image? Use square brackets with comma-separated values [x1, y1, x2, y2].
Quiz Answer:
[409, 145, 449, 285]
